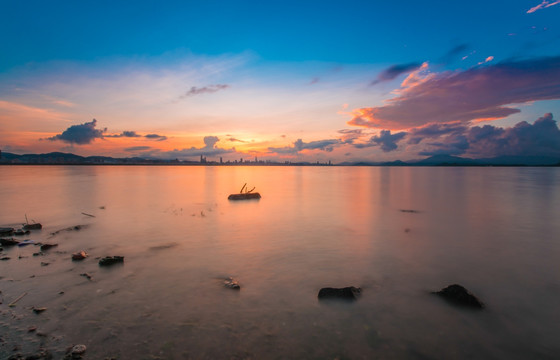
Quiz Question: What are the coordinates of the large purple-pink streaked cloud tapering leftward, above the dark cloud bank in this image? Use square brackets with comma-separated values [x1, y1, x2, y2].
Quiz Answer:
[348, 56, 560, 129]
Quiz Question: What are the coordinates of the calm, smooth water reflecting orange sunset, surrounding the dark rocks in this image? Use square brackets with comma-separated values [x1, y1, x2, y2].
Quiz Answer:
[0, 166, 560, 359]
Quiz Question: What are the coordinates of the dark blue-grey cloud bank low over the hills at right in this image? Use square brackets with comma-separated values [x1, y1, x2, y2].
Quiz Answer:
[409, 113, 560, 158]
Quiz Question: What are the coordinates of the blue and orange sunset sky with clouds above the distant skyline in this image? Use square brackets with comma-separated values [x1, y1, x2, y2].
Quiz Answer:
[0, 0, 560, 163]
